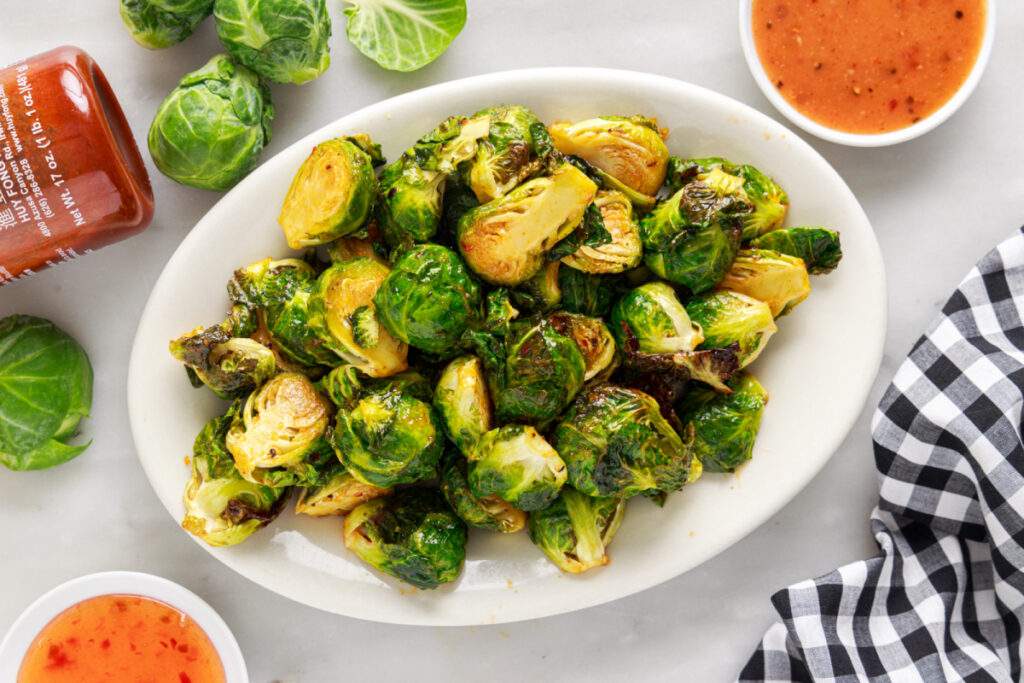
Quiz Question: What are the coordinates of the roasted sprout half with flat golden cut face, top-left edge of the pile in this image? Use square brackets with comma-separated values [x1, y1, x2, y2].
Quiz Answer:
[278, 137, 377, 249]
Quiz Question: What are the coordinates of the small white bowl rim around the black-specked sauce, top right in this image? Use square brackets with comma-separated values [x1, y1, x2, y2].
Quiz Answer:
[739, 0, 995, 147]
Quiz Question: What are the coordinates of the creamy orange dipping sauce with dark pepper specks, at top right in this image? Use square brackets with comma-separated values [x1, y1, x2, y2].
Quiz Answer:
[753, 0, 986, 133]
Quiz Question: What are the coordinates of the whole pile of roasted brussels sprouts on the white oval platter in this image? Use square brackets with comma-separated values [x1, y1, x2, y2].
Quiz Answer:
[171, 105, 842, 588]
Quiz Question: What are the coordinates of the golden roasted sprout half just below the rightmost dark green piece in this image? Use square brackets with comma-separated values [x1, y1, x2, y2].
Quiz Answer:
[720, 249, 811, 317]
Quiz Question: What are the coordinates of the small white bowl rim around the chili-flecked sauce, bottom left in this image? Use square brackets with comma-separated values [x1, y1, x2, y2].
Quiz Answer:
[0, 571, 249, 683]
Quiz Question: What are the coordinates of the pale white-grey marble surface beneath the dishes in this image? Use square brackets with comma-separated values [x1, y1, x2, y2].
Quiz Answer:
[0, 0, 1024, 683]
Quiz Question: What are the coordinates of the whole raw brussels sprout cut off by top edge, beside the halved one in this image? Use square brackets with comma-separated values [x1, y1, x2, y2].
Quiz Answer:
[213, 0, 331, 83]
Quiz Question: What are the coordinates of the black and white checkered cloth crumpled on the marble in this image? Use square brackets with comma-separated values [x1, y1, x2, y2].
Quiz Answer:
[739, 232, 1024, 683]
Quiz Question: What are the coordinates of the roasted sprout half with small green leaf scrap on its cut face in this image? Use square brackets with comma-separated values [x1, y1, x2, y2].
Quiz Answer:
[309, 257, 409, 377]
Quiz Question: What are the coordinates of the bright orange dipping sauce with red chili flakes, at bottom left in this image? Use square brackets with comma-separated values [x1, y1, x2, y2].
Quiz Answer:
[17, 595, 224, 683]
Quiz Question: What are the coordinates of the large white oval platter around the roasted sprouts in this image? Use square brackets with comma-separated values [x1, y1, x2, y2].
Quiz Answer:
[128, 69, 886, 625]
